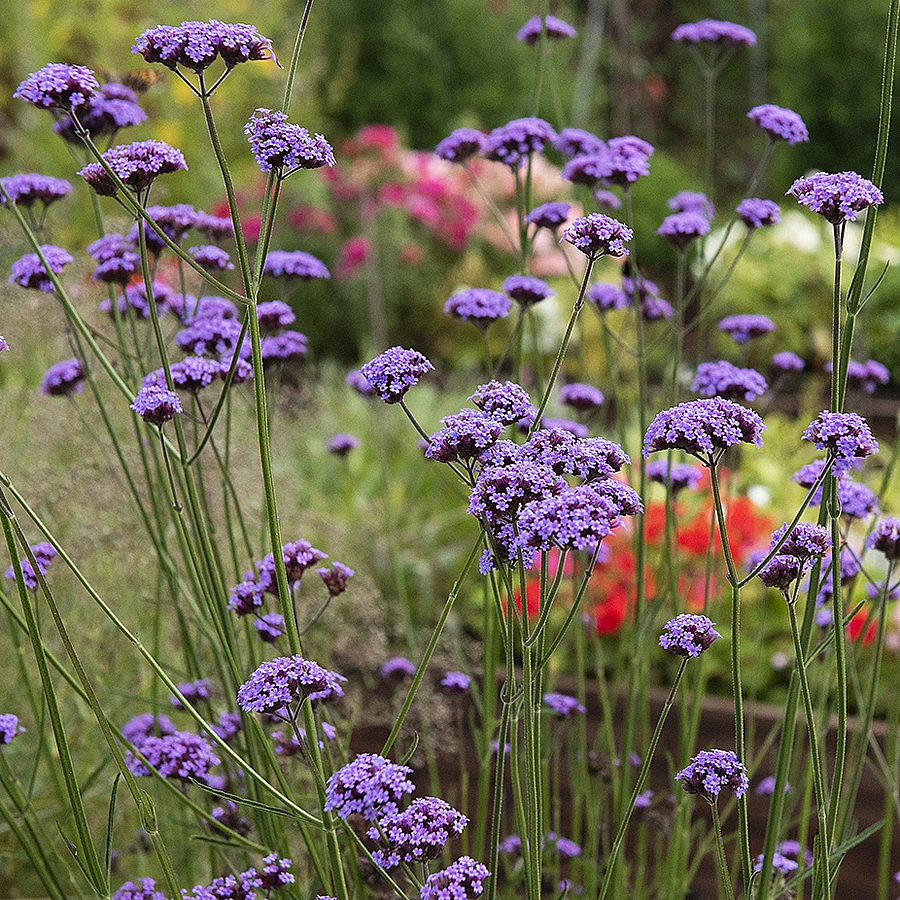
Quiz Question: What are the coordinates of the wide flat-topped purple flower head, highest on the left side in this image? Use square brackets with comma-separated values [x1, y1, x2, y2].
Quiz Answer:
[131, 19, 275, 73]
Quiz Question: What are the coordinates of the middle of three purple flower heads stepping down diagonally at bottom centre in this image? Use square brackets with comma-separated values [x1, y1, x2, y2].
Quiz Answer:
[367, 797, 469, 869]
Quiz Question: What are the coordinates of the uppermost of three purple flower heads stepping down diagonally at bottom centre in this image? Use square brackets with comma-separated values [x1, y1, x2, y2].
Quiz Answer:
[325, 753, 415, 822]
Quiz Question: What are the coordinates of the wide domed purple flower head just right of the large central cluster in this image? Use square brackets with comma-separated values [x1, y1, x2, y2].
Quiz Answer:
[644, 397, 766, 459]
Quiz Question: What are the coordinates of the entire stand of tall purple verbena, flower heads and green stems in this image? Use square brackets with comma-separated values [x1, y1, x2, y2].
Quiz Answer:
[0, 3, 900, 900]
